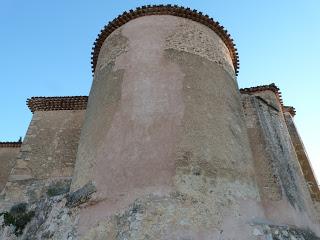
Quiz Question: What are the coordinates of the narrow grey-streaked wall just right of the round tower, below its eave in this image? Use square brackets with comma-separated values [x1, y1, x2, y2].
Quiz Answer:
[242, 87, 318, 231]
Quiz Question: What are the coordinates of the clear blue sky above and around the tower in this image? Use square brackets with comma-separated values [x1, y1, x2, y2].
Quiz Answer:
[0, 0, 320, 179]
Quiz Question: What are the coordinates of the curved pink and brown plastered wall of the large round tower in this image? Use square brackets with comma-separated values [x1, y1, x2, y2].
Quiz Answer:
[72, 16, 263, 239]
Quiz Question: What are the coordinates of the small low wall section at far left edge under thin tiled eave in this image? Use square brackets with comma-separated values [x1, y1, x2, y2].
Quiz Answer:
[0, 147, 20, 192]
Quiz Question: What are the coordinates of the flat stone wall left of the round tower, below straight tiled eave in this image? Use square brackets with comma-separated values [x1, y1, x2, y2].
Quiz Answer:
[2, 110, 85, 208]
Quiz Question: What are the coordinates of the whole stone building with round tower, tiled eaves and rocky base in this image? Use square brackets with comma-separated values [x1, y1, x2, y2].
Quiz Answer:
[0, 5, 320, 240]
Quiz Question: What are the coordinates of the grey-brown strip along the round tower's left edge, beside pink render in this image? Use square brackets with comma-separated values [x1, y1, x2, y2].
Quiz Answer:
[72, 31, 127, 190]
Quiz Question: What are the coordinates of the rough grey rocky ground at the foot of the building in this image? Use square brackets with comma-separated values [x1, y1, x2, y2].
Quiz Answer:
[0, 183, 320, 240]
